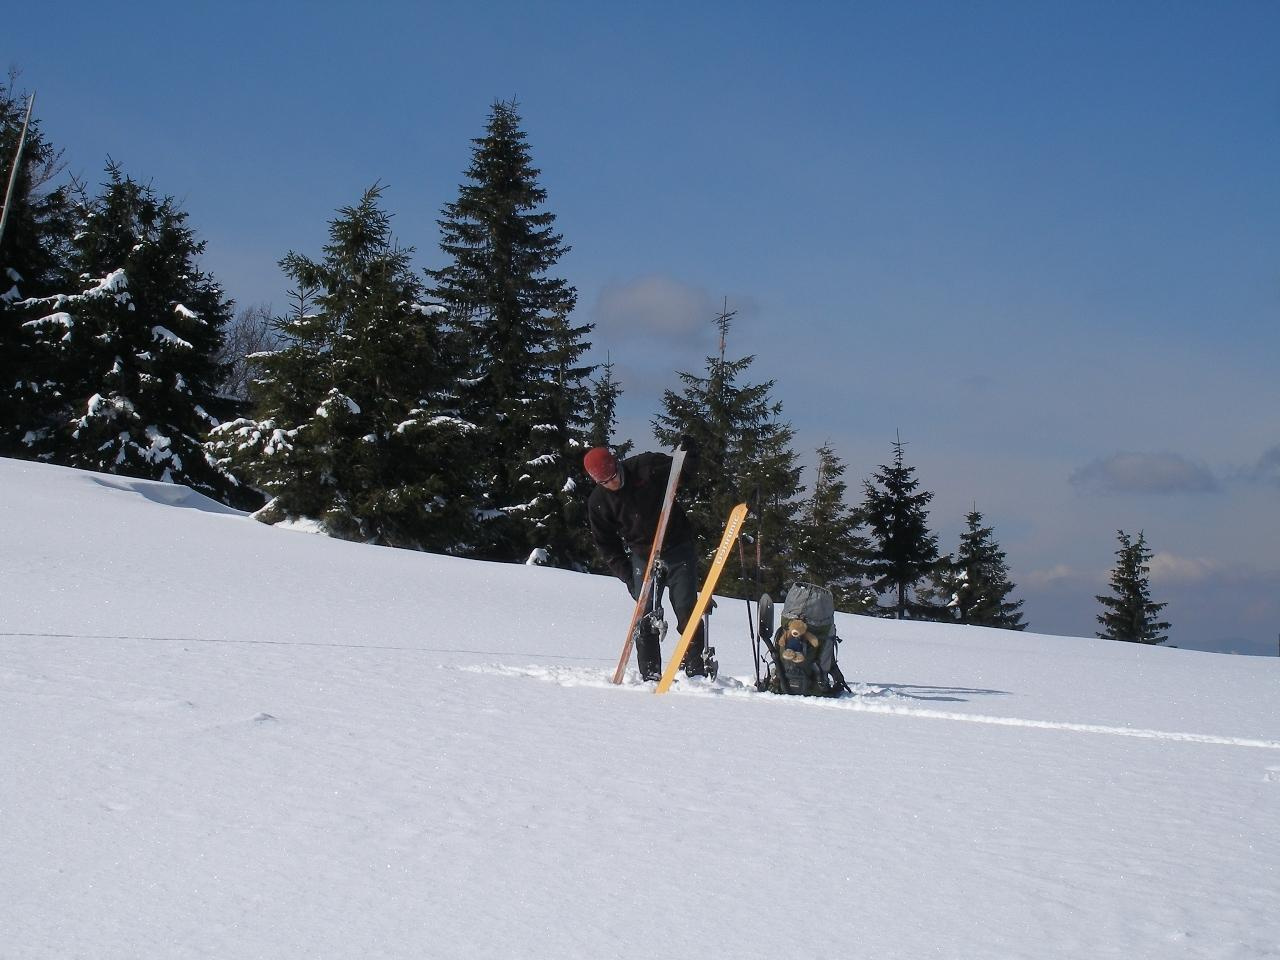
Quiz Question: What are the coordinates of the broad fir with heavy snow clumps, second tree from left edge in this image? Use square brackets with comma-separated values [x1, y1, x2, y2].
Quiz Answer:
[17, 164, 234, 500]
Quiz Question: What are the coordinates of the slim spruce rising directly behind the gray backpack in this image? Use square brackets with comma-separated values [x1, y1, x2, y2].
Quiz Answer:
[792, 443, 876, 613]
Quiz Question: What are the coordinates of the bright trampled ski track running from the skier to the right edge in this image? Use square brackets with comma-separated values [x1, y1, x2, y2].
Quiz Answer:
[460, 663, 1280, 757]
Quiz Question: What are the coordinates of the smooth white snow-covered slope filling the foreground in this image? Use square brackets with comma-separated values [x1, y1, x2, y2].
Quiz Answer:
[0, 460, 1280, 960]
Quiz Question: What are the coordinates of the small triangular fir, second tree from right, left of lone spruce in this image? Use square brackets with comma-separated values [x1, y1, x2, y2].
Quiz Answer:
[920, 507, 1027, 630]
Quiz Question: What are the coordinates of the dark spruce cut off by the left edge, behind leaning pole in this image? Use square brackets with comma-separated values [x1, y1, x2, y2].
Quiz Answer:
[0, 72, 74, 457]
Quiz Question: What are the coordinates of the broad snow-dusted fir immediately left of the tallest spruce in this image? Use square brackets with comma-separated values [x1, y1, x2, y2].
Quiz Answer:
[210, 186, 476, 553]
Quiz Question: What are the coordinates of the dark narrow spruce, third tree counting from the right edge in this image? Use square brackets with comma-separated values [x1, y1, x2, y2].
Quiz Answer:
[861, 440, 938, 620]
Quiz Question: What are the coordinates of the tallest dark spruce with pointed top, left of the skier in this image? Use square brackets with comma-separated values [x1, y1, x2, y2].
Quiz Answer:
[428, 102, 593, 567]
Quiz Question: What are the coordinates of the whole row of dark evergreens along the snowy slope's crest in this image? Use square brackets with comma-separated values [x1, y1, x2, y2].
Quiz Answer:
[0, 74, 1169, 643]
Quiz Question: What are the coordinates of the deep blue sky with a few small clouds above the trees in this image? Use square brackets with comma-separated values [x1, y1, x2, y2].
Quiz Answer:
[5, 3, 1280, 654]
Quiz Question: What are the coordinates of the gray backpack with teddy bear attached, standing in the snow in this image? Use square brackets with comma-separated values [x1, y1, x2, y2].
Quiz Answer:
[760, 581, 849, 696]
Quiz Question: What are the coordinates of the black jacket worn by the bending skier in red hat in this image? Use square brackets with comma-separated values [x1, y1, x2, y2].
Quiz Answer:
[586, 453, 692, 584]
